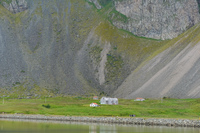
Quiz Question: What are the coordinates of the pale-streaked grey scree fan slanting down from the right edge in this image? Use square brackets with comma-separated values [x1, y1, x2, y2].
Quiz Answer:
[115, 24, 200, 98]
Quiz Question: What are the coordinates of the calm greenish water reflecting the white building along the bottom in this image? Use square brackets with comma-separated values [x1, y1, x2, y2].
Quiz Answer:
[0, 120, 200, 133]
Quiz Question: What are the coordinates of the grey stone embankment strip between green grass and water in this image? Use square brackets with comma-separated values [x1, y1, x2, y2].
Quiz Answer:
[0, 114, 200, 128]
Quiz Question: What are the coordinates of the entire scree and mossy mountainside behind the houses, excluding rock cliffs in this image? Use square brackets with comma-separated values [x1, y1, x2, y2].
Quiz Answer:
[0, 0, 200, 98]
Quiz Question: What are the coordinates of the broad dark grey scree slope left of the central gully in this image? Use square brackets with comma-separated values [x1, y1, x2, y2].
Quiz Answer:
[0, 0, 101, 94]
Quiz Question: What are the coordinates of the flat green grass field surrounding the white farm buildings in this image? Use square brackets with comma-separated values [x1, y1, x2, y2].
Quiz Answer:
[0, 97, 200, 119]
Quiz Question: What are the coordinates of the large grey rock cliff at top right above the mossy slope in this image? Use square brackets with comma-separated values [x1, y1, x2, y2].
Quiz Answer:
[113, 0, 200, 40]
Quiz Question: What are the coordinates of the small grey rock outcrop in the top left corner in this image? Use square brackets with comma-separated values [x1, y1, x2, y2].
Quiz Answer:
[3, 0, 28, 13]
